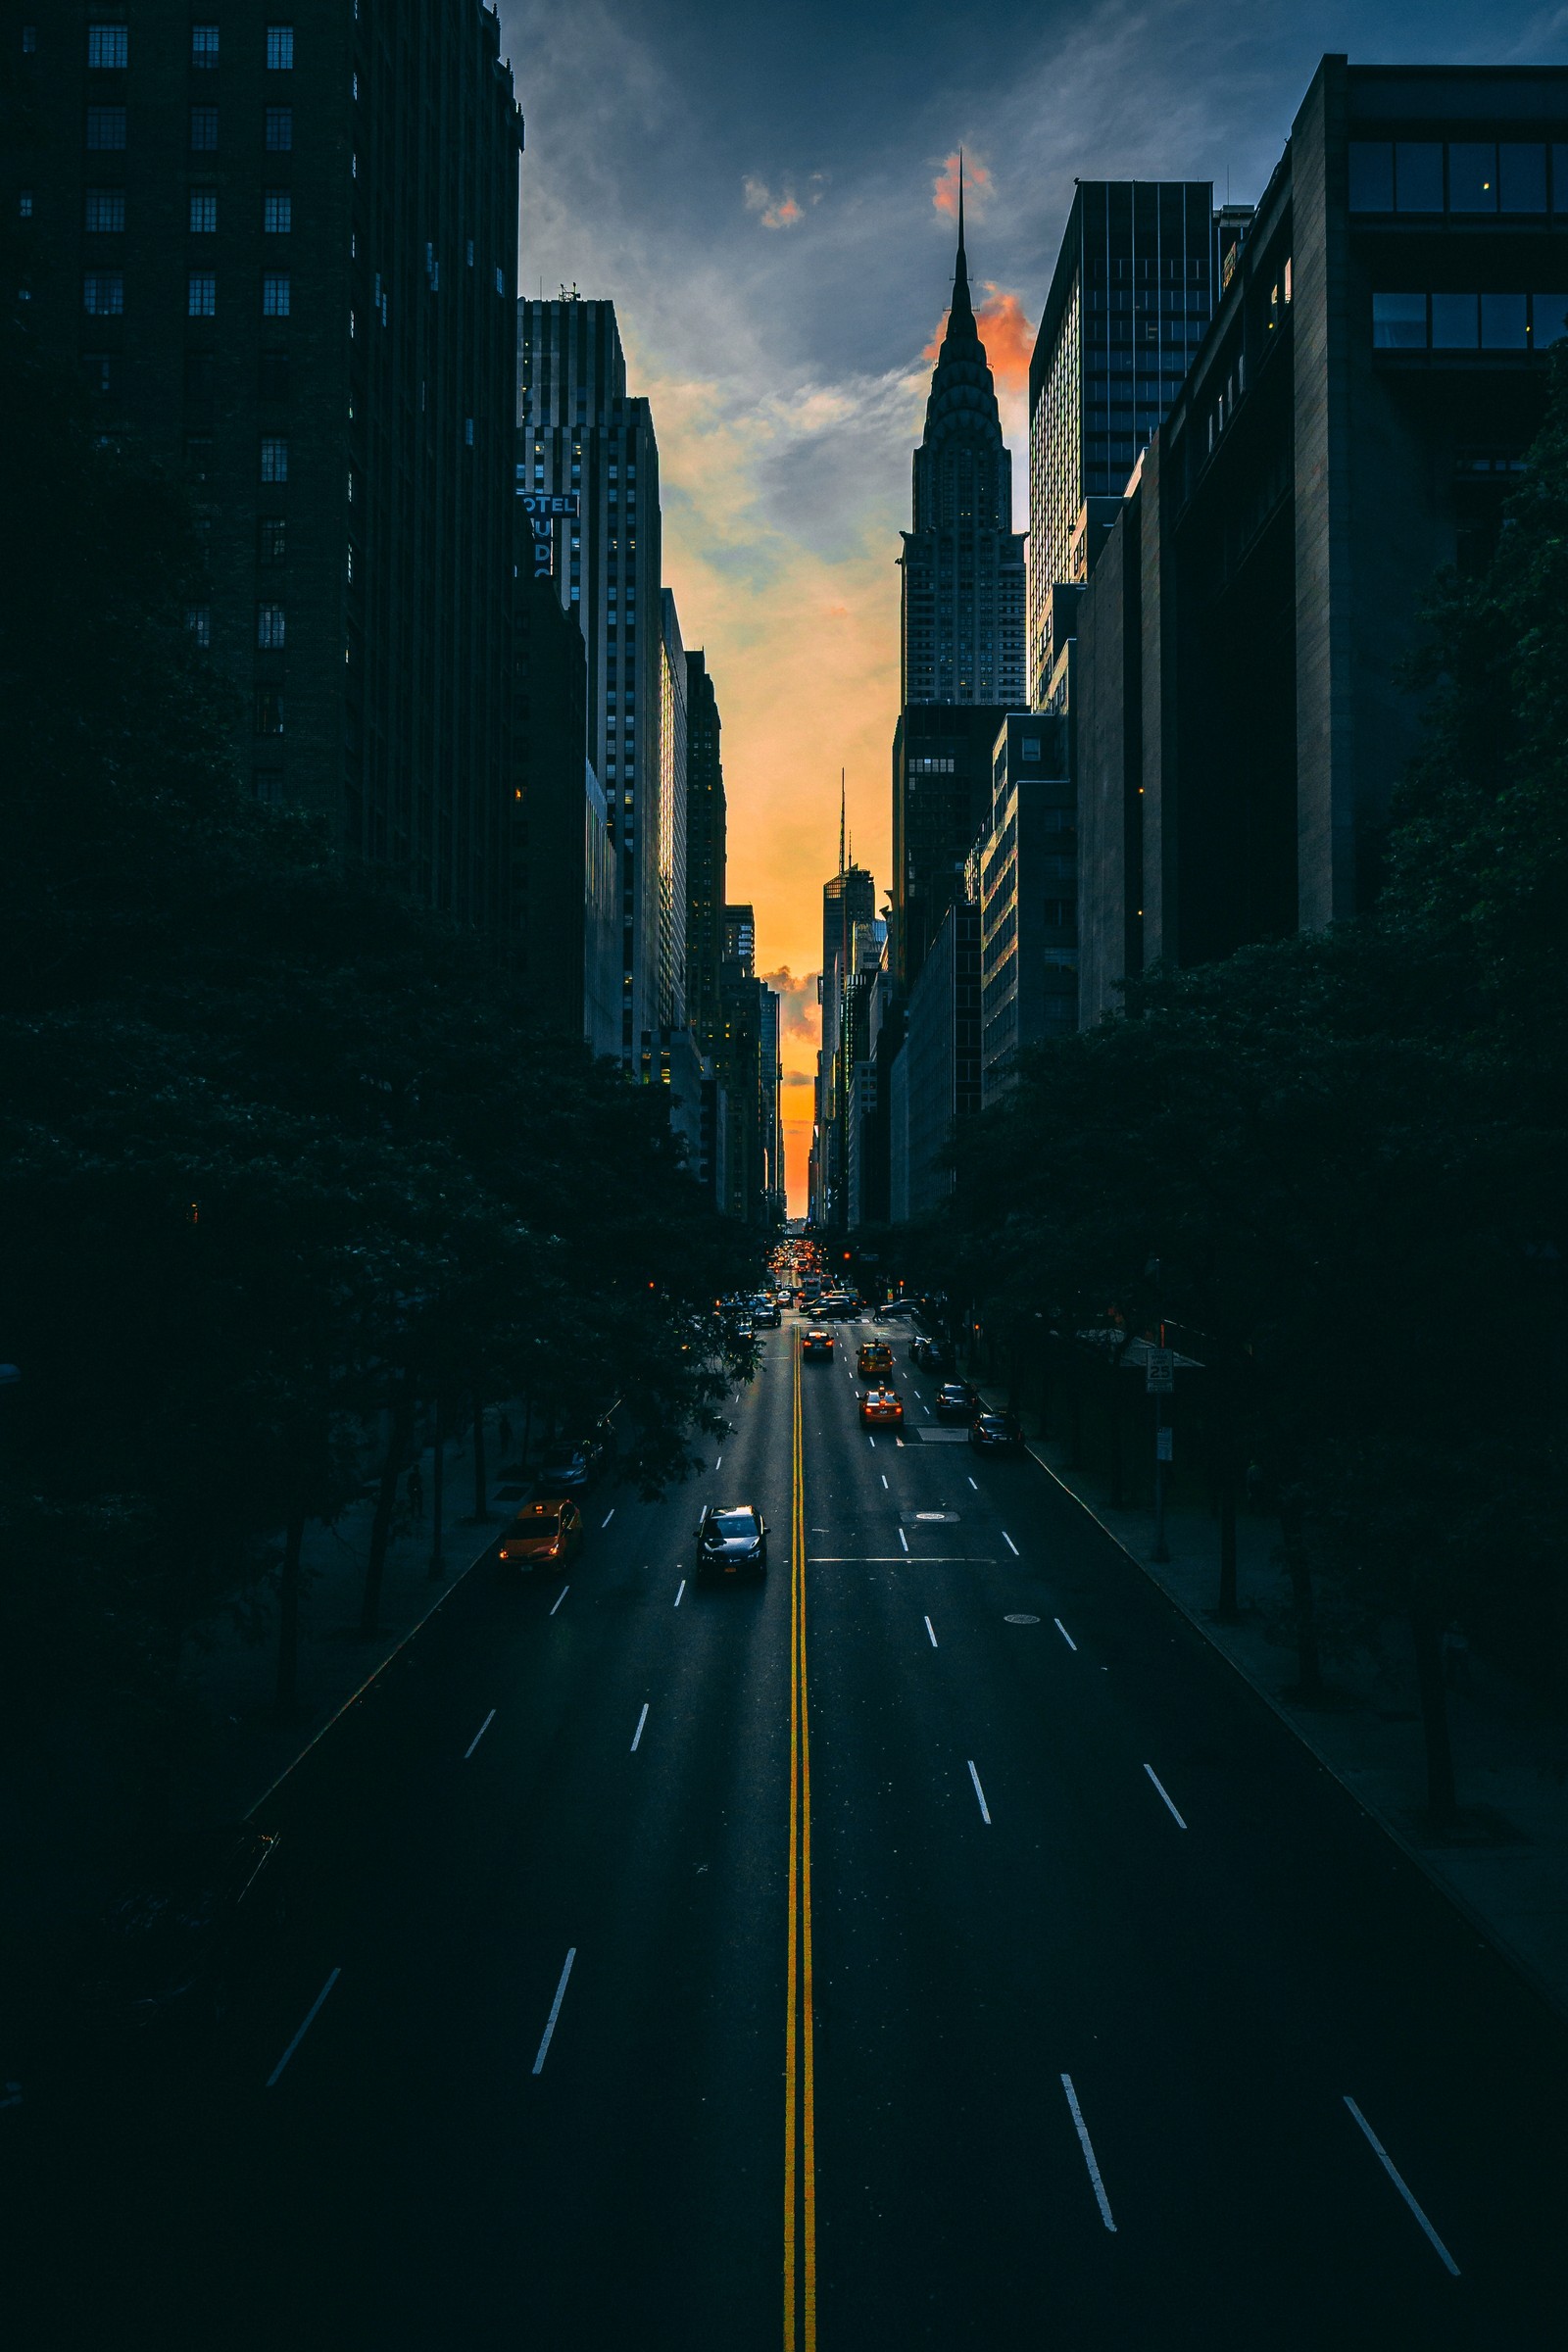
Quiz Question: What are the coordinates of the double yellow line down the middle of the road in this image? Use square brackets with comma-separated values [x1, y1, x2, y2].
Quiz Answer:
[785, 1334, 815, 2352]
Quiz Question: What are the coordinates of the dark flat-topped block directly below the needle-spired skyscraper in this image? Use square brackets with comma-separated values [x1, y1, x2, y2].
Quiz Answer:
[891, 704, 1006, 995]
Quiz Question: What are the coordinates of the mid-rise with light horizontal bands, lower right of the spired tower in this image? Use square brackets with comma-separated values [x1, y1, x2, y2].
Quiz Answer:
[971, 715, 1079, 1107]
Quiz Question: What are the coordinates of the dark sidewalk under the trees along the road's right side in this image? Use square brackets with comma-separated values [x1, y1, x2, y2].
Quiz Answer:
[980, 1388, 1568, 2016]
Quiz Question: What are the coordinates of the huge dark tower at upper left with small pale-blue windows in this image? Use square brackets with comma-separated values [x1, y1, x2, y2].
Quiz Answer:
[0, 0, 522, 924]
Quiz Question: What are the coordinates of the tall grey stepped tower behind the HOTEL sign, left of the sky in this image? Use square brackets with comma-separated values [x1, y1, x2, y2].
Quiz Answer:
[517, 296, 672, 1068]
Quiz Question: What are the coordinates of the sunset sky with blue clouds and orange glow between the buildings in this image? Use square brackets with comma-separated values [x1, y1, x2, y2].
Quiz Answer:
[501, 0, 1568, 1213]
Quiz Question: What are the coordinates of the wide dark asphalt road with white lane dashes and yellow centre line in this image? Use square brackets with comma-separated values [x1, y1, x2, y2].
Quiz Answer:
[10, 1317, 1568, 2352]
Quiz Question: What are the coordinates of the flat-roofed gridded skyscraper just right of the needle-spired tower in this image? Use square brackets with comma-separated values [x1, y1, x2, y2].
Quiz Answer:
[1029, 178, 1246, 710]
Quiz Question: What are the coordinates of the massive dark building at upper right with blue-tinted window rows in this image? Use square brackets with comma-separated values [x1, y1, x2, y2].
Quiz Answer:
[1079, 57, 1568, 1018]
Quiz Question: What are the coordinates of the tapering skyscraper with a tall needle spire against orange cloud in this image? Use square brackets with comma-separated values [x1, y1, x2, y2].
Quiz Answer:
[901, 179, 1027, 708]
